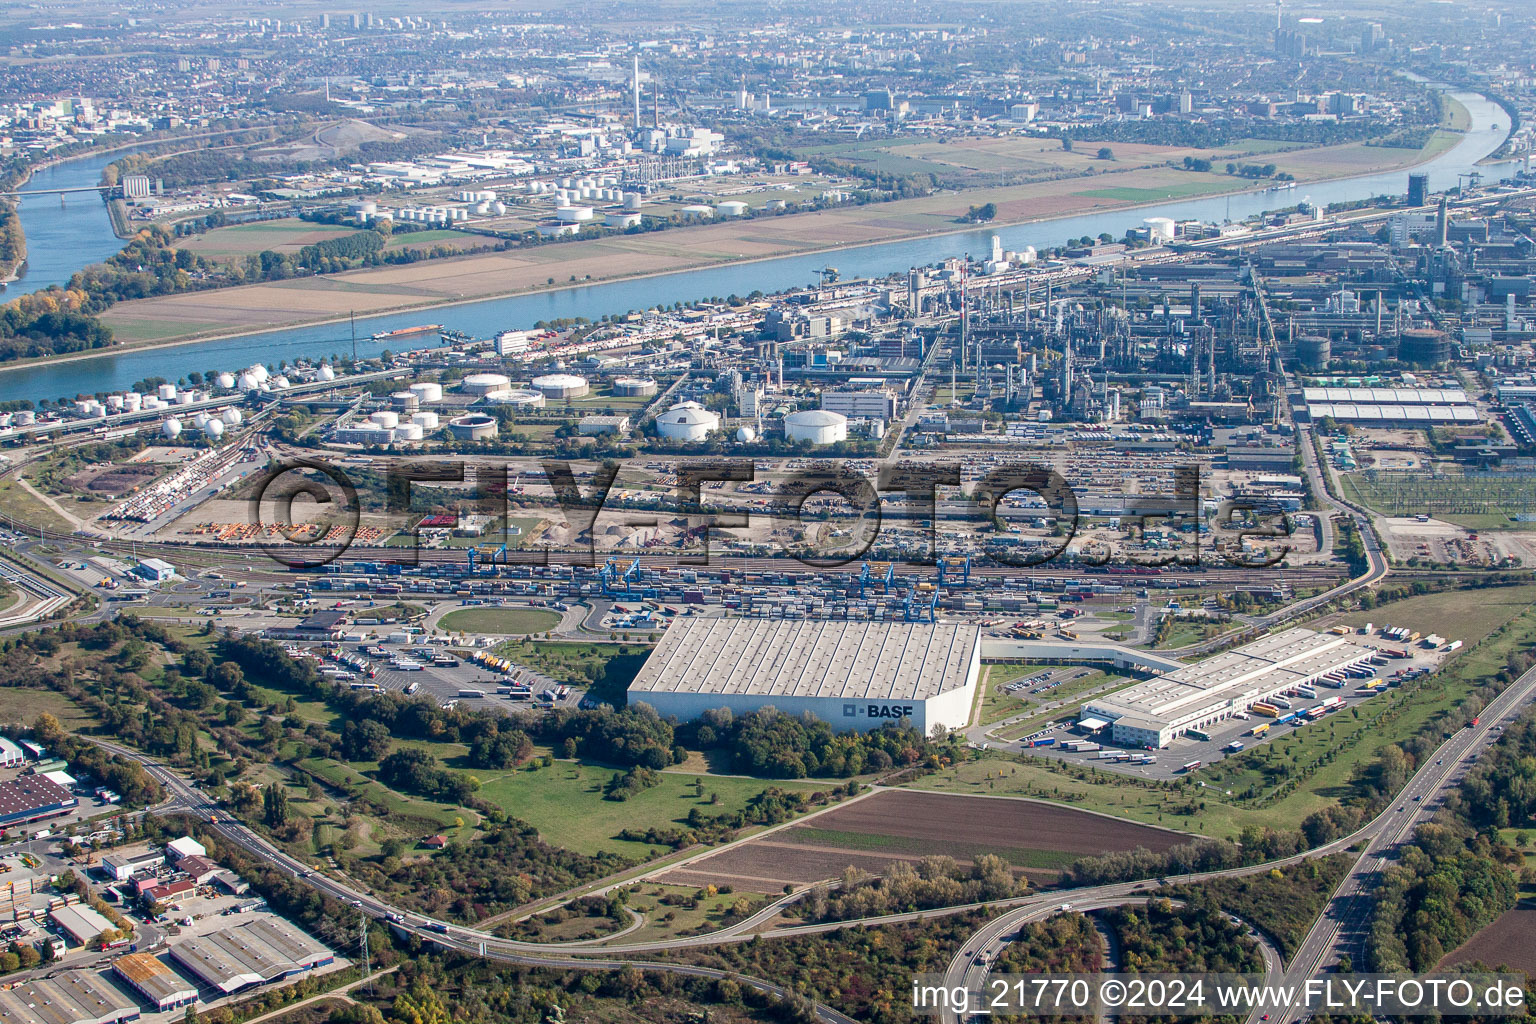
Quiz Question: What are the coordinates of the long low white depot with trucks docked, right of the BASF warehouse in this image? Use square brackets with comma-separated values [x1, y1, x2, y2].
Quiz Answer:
[1078, 628, 1376, 748]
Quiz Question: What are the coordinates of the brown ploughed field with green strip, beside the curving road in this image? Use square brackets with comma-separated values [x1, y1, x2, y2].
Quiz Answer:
[660, 789, 1187, 894]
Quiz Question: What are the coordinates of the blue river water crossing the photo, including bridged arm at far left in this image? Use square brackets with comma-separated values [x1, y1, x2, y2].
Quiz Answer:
[0, 92, 1518, 401]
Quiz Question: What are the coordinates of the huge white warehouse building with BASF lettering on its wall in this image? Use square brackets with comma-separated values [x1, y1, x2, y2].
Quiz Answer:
[630, 619, 982, 735]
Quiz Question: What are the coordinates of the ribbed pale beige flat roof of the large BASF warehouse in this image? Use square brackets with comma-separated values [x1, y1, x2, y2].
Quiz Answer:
[630, 619, 980, 700]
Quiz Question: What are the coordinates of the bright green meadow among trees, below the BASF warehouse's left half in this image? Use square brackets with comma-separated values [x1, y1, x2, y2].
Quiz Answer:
[478, 760, 828, 857]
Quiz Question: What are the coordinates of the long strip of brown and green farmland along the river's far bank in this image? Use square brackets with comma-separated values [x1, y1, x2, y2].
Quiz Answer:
[62, 135, 1458, 359]
